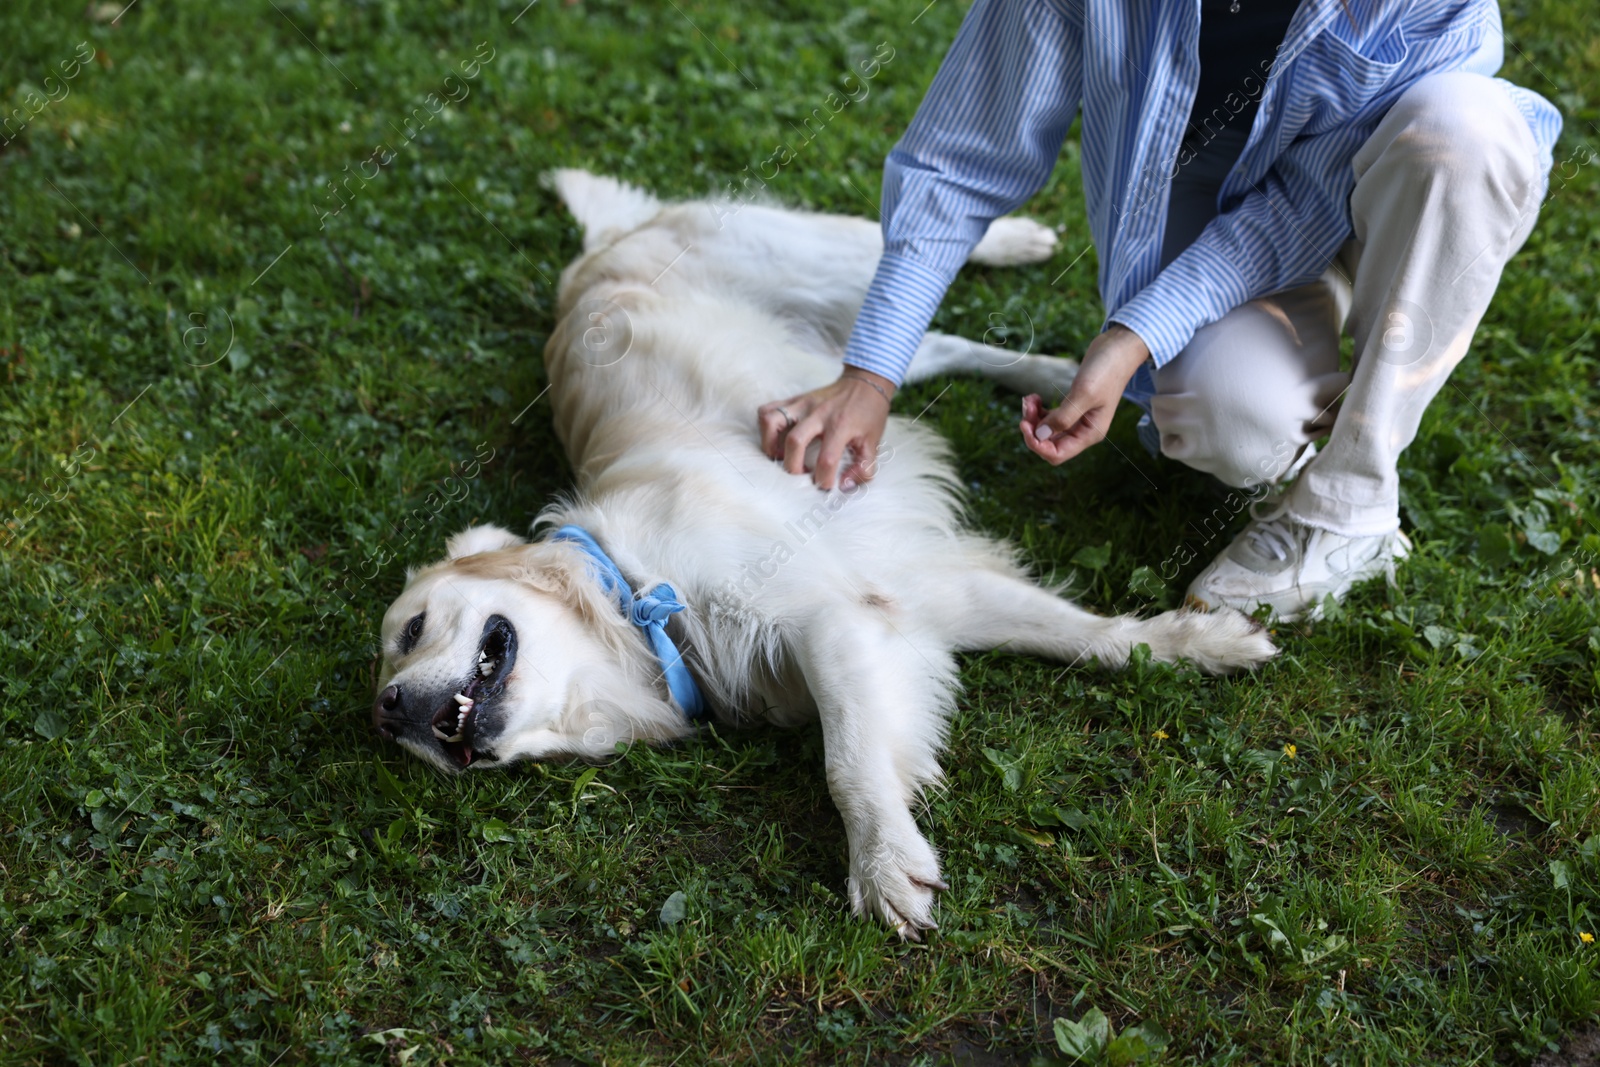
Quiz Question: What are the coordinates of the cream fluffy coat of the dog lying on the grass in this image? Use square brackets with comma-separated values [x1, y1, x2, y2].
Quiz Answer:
[373, 171, 1274, 936]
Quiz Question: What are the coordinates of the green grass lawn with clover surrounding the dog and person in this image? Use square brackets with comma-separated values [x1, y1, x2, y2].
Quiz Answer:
[0, 0, 1600, 1065]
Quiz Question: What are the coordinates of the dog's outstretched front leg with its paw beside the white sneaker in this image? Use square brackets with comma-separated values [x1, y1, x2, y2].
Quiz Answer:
[946, 569, 1277, 673]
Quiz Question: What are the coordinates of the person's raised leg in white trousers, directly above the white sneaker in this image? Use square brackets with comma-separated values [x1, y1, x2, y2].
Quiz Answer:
[1286, 72, 1544, 536]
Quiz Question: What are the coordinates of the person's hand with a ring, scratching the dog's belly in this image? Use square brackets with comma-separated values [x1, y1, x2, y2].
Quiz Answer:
[757, 366, 894, 491]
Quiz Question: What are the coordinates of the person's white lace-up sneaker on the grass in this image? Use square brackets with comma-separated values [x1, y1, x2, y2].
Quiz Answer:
[1189, 512, 1411, 622]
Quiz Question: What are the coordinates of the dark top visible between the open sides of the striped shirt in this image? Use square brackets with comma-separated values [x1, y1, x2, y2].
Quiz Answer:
[1162, 0, 1299, 267]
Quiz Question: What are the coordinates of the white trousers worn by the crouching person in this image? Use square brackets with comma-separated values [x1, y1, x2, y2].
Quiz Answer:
[1150, 72, 1546, 536]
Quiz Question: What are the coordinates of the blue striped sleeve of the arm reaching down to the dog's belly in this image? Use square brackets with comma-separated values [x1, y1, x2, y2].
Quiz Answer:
[845, 0, 1083, 382]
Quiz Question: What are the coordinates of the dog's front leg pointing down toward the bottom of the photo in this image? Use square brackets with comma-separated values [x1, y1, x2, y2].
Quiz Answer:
[795, 603, 955, 939]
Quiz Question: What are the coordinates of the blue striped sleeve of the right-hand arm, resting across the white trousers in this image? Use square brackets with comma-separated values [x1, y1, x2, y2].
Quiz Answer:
[1107, 3, 1542, 366]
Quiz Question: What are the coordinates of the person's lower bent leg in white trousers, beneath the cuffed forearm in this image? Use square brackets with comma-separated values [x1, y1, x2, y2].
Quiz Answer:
[1150, 272, 1349, 488]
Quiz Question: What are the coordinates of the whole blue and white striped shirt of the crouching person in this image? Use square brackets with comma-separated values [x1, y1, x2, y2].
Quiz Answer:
[845, 0, 1562, 402]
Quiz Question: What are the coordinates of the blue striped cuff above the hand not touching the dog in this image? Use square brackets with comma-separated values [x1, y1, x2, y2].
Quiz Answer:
[1106, 242, 1251, 366]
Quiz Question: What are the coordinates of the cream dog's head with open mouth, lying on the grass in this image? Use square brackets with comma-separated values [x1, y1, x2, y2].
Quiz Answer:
[373, 526, 678, 771]
